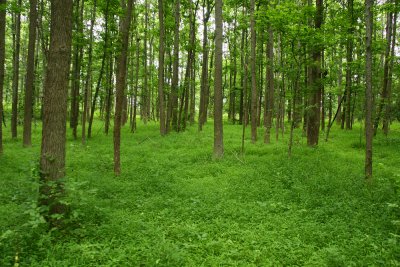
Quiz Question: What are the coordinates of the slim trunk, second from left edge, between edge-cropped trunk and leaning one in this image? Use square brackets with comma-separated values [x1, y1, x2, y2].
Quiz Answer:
[11, 0, 22, 138]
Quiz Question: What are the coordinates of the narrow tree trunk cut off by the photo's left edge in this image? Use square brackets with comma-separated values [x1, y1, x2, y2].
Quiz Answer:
[0, 0, 6, 155]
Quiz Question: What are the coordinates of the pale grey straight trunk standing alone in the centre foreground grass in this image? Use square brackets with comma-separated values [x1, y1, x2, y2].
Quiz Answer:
[214, 0, 224, 158]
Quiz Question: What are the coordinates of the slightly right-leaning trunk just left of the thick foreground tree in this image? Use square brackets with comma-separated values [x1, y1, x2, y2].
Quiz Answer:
[23, 0, 37, 147]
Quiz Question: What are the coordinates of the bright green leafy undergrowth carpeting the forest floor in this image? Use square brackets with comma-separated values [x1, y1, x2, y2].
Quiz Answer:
[0, 121, 400, 266]
